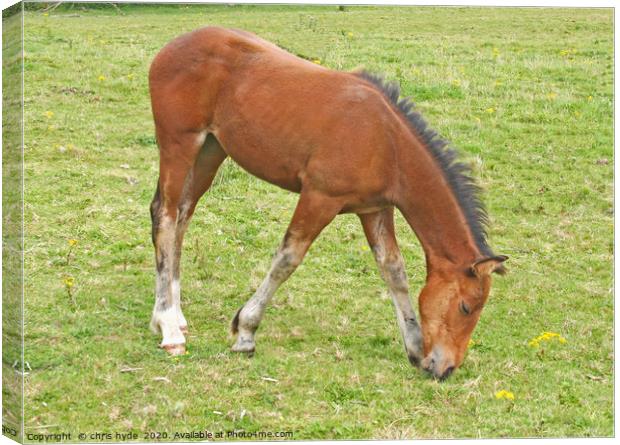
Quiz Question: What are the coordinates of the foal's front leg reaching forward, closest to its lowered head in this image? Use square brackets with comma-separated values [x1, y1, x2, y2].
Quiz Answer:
[359, 207, 423, 366]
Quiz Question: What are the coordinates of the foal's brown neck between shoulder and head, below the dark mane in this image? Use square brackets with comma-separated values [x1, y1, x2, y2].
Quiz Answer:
[398, 147, 480, 272]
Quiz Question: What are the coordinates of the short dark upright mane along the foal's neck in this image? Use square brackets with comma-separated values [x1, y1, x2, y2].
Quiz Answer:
[356, 71, 493, 257]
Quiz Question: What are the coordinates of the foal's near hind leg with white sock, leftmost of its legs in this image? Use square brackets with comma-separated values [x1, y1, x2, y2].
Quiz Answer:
[151, 127, 221, 354]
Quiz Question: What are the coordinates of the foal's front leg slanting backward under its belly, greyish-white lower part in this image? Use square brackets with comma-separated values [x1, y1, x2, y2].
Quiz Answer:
[232, 191, 342, 353]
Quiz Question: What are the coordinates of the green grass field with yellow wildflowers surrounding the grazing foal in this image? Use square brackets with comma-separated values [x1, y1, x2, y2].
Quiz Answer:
[20, 5, 614, 441]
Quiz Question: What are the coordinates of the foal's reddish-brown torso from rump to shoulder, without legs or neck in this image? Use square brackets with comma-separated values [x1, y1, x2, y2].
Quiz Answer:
[150, 27, 406, 199]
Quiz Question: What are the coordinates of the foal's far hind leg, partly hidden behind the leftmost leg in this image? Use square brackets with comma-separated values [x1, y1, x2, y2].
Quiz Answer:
[172, 135, 226, 334]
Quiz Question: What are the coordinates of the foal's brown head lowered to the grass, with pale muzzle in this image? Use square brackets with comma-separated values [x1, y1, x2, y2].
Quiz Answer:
[419, 256, 507, 379]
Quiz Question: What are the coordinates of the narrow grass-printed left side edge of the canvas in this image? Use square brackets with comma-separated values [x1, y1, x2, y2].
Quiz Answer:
[2, 8, 23, 440]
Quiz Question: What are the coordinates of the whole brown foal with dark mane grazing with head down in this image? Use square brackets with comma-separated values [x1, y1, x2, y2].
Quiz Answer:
[149, 27, 506, 378]
